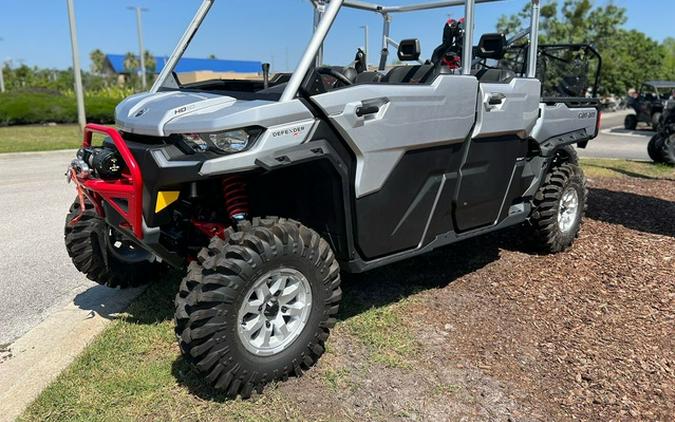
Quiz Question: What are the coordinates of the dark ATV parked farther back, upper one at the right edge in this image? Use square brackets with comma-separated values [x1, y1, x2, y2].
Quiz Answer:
[624, 81, 675, 131]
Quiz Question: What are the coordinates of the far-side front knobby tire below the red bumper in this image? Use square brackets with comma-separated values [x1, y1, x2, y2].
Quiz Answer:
[65, 200, 165, 288]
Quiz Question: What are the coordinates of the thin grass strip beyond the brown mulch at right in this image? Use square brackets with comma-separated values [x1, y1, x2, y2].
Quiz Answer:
[581, 158, 675, 180]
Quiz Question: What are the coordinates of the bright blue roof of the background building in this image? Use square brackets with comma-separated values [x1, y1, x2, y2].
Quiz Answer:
[106, 54, 262, 73]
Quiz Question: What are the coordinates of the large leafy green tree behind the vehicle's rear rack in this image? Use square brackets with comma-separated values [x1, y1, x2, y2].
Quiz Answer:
[497, 0, 665, 95]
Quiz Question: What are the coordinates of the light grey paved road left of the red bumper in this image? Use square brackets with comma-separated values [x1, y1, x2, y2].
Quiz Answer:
[0, 152, 95, 350]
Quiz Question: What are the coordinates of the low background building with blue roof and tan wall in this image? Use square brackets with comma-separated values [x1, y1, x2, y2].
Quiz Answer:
[106, 54, 262, 83]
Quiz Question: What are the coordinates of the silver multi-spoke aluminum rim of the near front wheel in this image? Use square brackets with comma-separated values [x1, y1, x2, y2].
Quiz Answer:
[237, 268, 312, 356]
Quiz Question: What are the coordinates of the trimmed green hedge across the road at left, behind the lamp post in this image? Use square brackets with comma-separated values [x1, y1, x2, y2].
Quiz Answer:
[0, 90, 122, 126]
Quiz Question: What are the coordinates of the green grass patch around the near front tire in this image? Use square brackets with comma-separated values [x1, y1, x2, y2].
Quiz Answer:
[19, 276, 416, 421]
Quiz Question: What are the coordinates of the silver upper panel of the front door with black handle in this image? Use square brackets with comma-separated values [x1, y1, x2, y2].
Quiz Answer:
[312, 75, 478, 198]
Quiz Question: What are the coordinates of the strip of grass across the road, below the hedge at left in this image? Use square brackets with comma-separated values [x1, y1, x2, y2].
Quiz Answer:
[0, 125, 82, 153]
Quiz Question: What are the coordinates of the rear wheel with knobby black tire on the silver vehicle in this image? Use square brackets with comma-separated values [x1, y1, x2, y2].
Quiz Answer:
[530, 163, 588, 253]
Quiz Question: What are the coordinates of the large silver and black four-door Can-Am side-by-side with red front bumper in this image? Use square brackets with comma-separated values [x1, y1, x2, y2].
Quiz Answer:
[65, 0, 600, 397]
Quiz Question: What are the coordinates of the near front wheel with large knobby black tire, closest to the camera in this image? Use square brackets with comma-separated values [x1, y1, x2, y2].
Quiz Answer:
[175, 217, 342, 398]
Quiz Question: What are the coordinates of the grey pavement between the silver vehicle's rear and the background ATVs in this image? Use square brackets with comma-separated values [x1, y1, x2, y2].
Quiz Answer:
[578, 112, 654, 161]
